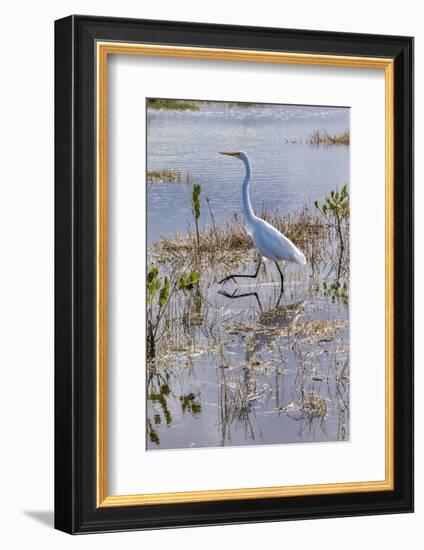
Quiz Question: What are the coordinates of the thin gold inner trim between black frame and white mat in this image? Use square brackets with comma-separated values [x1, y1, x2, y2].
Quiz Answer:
[96, 41, 394, 507]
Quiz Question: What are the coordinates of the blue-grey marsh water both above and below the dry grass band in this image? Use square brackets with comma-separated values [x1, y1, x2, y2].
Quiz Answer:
[146, 104, 349, 450]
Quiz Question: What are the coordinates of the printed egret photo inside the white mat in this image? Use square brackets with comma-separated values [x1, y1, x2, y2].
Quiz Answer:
[147, 98, 350, 450]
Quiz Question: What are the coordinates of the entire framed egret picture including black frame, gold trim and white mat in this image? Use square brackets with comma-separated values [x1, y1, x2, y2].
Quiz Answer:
[54, 20, 414, 534]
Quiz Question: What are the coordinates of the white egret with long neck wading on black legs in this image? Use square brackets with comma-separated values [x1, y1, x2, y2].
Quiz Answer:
[218, 151, 306, 292]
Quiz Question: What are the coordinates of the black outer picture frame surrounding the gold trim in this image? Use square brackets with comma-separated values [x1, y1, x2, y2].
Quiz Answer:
[55, 15, 413, 534]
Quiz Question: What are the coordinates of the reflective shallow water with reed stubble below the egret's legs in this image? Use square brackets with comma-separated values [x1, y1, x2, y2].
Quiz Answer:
[148, 266, 349, 449]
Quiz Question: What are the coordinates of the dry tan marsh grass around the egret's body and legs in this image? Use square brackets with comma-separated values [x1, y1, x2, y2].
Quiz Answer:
[149, 198, 349, 370]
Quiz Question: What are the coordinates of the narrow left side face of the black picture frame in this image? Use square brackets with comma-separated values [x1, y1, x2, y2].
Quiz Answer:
[54, 16, 77, 533]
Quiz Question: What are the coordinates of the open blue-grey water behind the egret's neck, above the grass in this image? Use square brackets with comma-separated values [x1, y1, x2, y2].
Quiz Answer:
[147, 103, 349, 248]
